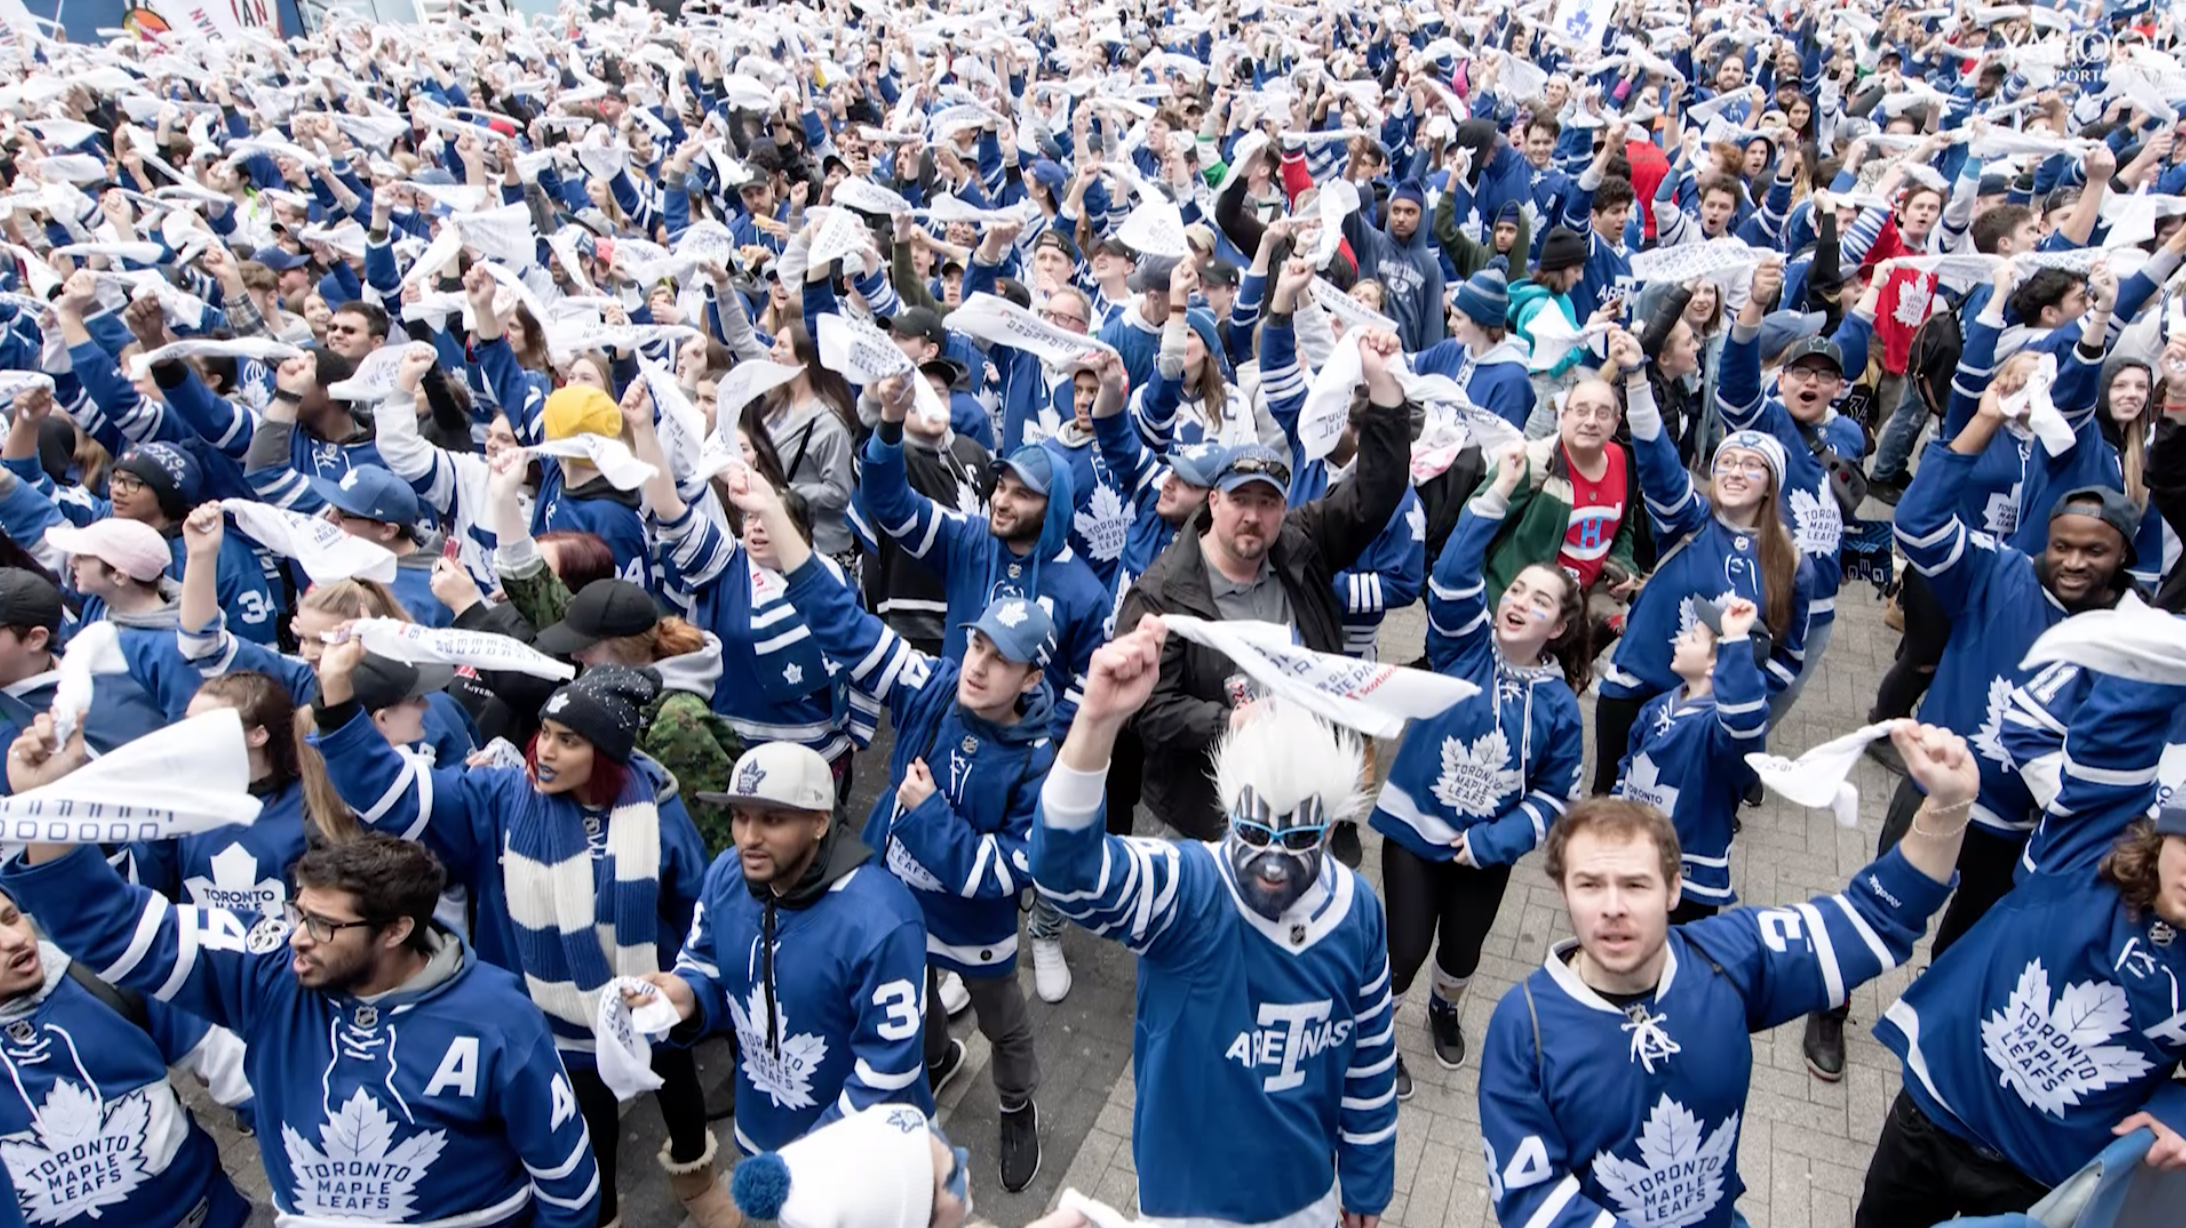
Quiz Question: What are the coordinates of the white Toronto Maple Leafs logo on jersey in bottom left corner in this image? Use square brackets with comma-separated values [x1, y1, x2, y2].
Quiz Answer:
[0, 1077, 153, 1224]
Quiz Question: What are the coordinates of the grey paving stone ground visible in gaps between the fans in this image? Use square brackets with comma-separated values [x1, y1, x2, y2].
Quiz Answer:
[197, 586, 1926, 1228]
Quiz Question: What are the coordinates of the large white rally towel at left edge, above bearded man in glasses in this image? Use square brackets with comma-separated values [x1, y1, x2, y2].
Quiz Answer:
[0, 708, 260, 843]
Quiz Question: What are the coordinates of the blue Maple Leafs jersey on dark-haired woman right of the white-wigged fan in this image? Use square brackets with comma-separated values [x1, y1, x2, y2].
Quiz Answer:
[1371, 487, 1585, 865]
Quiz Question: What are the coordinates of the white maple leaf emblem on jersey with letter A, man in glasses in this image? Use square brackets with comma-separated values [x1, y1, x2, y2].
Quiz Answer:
[280, 1088, 448, 1224]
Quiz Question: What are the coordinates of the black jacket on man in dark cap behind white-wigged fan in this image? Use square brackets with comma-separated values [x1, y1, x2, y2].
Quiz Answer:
[1115, 397, 1412, 839]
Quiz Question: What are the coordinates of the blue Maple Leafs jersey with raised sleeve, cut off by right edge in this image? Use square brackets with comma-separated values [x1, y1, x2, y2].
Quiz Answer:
[1876, 668, 2186, 1184]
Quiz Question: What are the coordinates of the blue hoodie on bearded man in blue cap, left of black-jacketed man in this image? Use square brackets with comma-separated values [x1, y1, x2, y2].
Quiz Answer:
[859, 422, 1110, 730]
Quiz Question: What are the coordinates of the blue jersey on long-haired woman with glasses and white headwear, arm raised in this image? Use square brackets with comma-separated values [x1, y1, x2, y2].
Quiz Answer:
[1602, 373, 1834, 699]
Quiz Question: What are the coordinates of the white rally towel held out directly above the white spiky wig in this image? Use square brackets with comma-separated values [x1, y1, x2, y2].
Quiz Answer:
[1163, 614, 1480, 739]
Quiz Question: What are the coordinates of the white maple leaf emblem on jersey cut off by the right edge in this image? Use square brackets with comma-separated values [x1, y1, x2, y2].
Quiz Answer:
[1981, 959, 2155, 1117]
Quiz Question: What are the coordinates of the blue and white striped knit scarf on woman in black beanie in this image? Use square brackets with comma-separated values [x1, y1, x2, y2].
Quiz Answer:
[501, 765, 660, 1031]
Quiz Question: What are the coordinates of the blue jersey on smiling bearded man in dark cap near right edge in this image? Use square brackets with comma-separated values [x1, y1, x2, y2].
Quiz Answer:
[1895, 444, 2066, 835]
